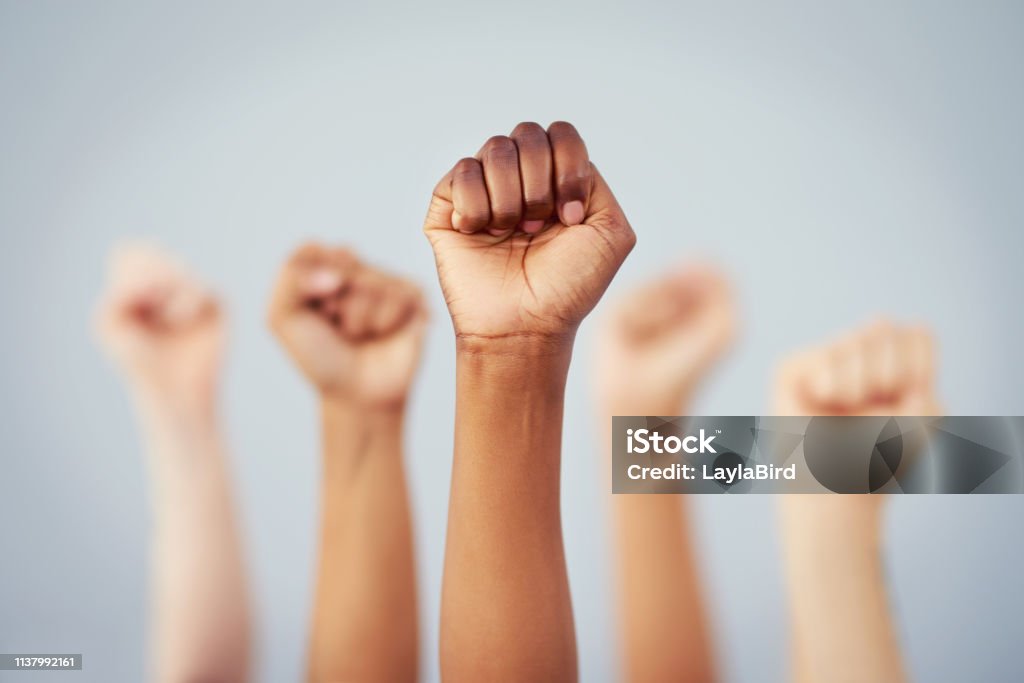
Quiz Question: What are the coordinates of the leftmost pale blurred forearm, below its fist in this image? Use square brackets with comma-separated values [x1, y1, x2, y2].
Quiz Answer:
[139, 400, 250, 683]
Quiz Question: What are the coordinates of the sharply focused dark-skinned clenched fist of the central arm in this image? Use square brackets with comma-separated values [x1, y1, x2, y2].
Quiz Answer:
[424, 122, 636, 343]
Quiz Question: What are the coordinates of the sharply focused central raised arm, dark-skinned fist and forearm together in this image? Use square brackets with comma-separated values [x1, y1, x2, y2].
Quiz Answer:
[424, 123, 635, 682]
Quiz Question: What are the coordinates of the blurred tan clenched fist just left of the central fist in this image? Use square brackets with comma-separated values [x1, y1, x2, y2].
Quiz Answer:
[269, 245, 427, 408]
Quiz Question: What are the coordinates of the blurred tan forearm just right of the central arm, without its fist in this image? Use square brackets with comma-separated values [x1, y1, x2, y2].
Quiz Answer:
[599, 405, 716, 683]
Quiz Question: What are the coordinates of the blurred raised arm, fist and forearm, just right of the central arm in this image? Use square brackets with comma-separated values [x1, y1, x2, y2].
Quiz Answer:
[594, 267, 735, 683]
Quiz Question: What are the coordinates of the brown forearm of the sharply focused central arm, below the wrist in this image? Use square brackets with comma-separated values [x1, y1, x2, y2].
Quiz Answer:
[441, 342, 577, 682]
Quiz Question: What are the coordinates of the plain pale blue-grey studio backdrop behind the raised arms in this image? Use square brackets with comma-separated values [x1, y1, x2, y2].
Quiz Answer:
[0, 0, 1024, 683]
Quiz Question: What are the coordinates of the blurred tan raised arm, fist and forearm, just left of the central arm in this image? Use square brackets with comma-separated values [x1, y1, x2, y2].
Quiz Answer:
[269, 244, 427, 683]
